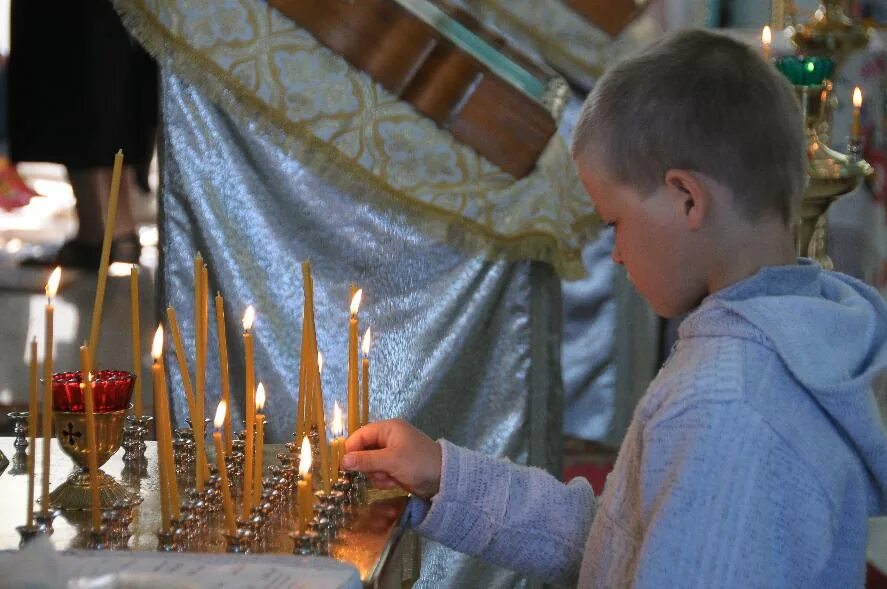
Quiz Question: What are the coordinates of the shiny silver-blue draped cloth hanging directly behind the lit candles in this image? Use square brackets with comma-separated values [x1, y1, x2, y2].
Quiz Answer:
[158, 71, 562, 588]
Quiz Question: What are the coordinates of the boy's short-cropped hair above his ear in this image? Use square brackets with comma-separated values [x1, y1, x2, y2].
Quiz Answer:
[572, 30, 807, 224]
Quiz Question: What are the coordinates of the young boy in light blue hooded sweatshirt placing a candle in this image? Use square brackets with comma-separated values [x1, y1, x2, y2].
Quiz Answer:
[345, 31, 887, 588]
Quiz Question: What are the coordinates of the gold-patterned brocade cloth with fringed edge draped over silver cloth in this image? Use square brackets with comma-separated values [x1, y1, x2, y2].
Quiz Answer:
[109, 0, 599, 279]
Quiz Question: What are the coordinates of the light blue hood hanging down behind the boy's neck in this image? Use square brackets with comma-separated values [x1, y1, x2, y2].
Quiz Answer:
[680, 258, 887, 513]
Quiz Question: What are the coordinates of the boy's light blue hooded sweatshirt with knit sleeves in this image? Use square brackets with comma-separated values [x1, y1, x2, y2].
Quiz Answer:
[410, 259, 887, 588]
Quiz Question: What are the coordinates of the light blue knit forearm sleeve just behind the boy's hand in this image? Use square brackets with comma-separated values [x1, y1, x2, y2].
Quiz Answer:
[413, 440, 595, 584]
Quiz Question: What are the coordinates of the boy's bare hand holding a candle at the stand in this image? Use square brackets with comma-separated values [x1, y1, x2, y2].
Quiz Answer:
[342, 419, 441, 499]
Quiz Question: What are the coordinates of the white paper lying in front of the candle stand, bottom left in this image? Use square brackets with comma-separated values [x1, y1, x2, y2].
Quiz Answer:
[0, 542, 361, 589]
